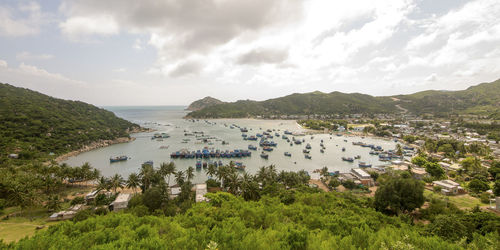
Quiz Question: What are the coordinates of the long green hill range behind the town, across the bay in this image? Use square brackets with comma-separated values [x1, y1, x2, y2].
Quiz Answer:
[187, 80, 500, 119]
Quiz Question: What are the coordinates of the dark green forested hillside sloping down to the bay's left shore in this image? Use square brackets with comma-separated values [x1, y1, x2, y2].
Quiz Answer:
[0, 84, 139, 161]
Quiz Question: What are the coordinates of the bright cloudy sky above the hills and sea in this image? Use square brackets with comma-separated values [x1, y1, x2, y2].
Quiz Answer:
[0, 0, 500, 106]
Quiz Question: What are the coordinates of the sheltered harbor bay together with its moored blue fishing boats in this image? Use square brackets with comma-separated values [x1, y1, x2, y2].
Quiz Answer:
[65, 108, 396, 181]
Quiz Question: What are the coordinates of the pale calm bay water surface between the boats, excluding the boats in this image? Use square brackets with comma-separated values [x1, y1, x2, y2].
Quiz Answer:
[65, 106, 395, 182]
